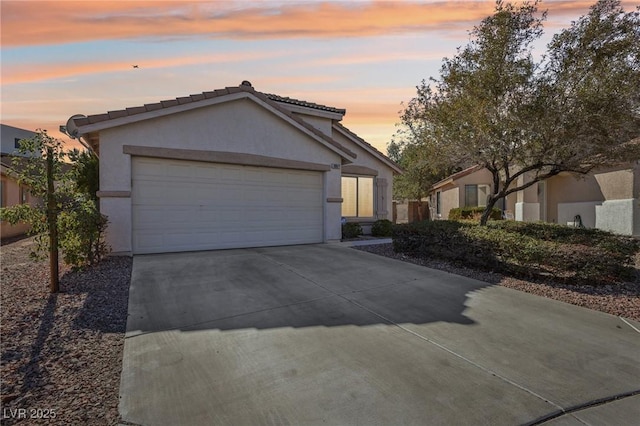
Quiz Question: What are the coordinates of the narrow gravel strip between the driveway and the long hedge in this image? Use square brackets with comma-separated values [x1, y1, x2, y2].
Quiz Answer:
[354, 244, 640, 321]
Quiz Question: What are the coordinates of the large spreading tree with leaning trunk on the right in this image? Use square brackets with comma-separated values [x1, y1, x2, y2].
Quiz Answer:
[402, 0, 640, 224]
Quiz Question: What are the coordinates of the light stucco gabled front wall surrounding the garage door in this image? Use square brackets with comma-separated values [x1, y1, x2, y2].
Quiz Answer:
[100, 99, 341, 253]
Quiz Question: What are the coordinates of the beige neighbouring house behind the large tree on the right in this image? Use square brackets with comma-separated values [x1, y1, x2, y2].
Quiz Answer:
[431, 162, 640, 235]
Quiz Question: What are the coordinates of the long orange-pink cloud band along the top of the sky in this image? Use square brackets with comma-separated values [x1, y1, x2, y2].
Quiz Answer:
[1, 0, 494, 47]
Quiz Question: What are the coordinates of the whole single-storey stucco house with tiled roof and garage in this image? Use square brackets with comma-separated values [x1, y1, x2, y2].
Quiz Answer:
[67, 81, 400, 254]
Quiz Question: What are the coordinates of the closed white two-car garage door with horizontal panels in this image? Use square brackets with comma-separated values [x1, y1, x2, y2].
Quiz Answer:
[131, 157, 323, 254]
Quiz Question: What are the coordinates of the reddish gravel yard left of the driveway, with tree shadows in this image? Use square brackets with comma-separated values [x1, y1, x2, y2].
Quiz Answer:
[0, 239, 131, 425]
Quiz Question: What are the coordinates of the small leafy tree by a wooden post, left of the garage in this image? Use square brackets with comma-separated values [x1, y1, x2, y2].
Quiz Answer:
[0, 130, 107, 293]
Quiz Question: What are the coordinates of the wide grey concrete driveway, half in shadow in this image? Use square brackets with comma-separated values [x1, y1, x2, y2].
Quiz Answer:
[120, 245, 640, 425]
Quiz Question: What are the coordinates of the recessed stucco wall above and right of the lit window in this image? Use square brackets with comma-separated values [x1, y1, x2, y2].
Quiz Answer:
[331, 131, 393, 226]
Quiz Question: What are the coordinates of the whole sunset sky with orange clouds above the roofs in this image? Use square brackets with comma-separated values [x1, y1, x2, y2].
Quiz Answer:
[0, 0, 640, 152]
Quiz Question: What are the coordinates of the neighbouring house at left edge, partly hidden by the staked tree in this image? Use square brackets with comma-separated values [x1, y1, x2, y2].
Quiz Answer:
[0, 124, 36, 239]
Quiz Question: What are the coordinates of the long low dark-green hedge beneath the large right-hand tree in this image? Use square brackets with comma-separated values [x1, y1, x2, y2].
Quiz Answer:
[393, 221, 640, 284]
